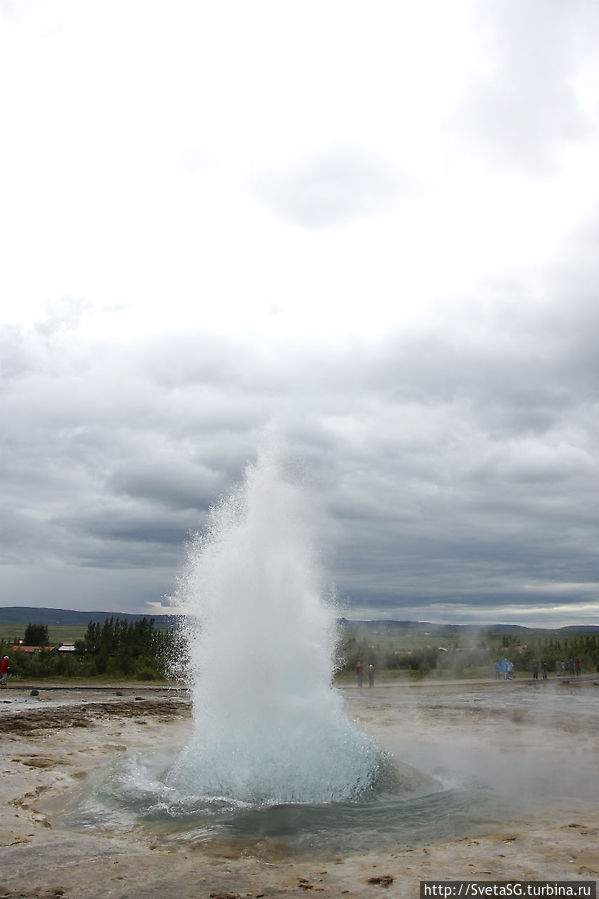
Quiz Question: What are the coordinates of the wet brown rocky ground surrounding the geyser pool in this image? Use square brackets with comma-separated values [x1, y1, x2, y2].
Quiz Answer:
[0, 679, 599, 899]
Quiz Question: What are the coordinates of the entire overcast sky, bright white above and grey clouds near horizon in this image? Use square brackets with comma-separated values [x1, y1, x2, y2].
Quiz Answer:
[0, 0, 599, 626]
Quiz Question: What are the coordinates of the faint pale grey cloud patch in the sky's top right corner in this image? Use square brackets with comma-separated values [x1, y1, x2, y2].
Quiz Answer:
[464, 0, 599, 174]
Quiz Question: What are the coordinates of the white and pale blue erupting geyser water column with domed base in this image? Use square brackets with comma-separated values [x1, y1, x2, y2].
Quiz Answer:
[167, 453, 383, 805]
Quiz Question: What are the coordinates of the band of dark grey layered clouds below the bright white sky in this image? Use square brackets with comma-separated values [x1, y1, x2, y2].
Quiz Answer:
[1, 264, 599, 618]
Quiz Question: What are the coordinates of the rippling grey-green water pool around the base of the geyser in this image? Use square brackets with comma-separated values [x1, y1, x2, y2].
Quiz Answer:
[61, 751, 505, 854]
